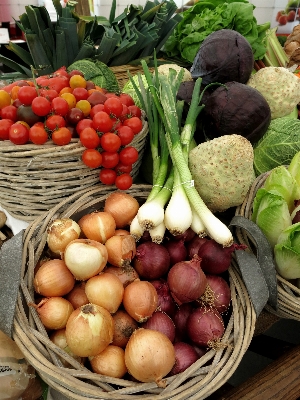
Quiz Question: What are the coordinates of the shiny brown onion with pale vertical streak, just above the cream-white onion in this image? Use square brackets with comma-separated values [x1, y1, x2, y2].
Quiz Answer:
[78, 211, 116, 244]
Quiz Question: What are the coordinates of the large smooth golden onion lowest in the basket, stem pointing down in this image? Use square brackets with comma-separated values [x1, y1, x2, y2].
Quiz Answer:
[125, 328, 175, 387]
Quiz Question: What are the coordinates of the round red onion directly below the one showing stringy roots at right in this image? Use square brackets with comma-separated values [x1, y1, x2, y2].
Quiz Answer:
[187, 306, 225, 347]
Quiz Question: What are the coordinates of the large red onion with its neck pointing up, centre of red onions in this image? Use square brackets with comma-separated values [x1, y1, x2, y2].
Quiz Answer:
[167, 256, 206, 305]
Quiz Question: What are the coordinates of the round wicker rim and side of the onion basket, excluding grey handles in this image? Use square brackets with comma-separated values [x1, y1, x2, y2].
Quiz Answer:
[13, 184, 256, 400]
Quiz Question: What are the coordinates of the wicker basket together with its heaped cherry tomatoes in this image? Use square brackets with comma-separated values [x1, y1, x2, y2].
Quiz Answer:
[0, 68, 148, 221]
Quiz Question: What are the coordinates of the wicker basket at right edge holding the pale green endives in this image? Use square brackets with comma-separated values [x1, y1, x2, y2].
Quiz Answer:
[236, 171, 300, 321]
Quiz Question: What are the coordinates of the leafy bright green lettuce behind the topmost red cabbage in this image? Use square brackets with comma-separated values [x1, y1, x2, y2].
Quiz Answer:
[163, 0, 270, 64]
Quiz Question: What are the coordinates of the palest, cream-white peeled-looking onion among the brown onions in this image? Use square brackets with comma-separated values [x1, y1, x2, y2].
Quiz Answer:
[63, 239, 107, 281]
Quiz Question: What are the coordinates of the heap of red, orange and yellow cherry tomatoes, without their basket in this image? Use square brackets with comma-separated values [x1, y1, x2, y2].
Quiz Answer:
[0, 67, 143, 190]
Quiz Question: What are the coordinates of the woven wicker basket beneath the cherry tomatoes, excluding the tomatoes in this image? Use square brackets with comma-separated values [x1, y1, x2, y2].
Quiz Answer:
[0, 114, 148, 222]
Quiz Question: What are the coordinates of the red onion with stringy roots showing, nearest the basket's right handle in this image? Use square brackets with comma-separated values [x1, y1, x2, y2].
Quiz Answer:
[199, 275, 231, 313]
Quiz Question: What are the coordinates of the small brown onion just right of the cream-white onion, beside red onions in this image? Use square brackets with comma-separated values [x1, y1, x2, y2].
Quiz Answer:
[105, 235, 136, 267]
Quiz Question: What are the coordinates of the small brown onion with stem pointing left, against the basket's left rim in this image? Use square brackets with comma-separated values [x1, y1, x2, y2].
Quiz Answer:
[30, 297, 74, 329]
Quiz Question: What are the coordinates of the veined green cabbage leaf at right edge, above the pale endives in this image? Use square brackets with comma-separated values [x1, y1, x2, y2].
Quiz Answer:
[253, 117, 300, 176]
